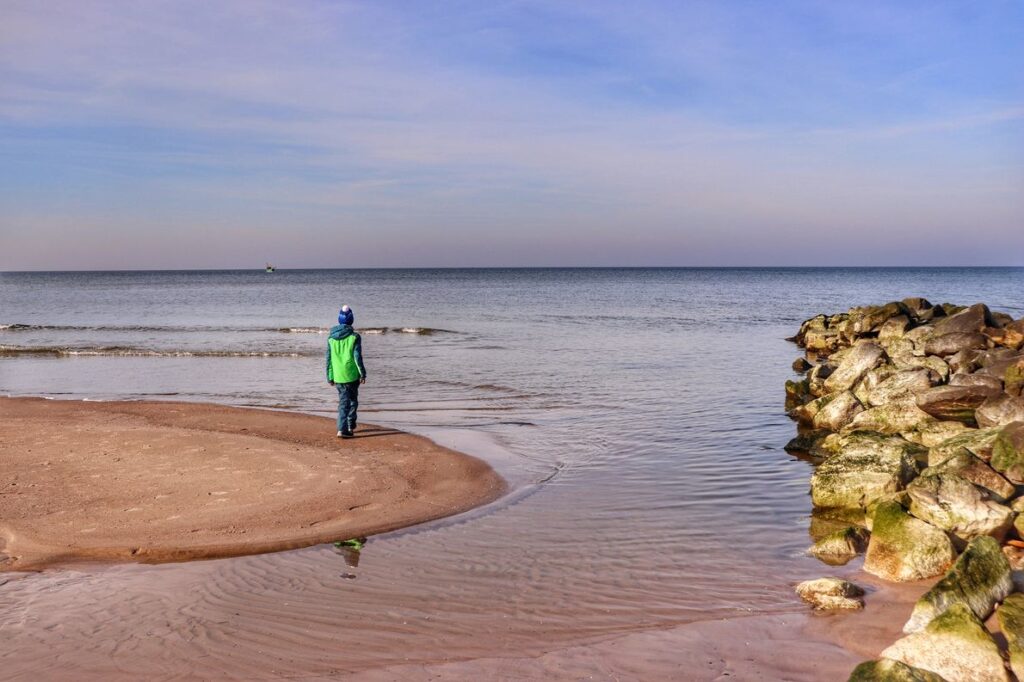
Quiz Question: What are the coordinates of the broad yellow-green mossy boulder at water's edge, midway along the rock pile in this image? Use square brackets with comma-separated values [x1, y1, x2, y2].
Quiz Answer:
[811, 431, 924, 509]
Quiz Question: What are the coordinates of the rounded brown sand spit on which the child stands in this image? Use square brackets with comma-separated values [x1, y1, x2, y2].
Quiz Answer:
[0, 398, 505, 570]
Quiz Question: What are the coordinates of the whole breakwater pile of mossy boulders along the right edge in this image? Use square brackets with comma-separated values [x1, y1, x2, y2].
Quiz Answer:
[785, 298, 1024, 682]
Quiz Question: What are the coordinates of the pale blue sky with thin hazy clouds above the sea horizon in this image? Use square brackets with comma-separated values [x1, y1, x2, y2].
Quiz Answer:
[0, 0, 1024, 270]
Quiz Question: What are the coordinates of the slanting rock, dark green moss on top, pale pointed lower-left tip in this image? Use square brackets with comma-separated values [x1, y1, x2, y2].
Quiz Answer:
[903, 536, 1014, 634]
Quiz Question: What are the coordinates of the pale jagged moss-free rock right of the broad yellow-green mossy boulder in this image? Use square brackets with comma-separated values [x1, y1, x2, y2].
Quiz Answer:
[906, 469, 1014, 543]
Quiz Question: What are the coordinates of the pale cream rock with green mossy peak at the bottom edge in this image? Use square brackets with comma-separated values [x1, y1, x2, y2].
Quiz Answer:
[882, 604, 1009, 682]
